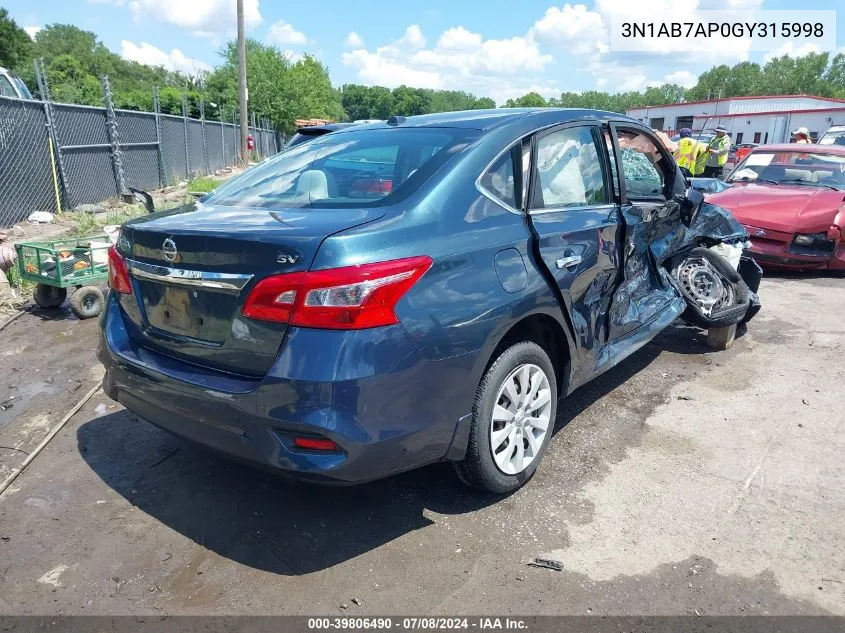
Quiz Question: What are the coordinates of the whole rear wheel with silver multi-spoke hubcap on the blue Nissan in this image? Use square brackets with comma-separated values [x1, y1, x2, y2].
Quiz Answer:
[456, 342, 557, 494]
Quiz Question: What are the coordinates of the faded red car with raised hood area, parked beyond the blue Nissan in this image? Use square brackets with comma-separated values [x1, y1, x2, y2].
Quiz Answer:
[707, 143, 845, 271]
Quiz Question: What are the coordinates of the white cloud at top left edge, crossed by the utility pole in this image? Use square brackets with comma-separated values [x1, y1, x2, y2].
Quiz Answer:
[129, 0, 262, 36]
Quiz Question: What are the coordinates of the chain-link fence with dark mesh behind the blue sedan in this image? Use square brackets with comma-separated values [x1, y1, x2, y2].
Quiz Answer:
[0, 81, 281, 227]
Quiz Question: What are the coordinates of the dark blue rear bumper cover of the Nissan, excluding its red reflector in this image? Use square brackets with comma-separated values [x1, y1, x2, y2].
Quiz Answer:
[98, 296, 478, 484]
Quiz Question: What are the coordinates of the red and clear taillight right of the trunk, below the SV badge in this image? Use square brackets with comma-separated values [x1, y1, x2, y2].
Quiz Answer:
[243, 257, 431, 330]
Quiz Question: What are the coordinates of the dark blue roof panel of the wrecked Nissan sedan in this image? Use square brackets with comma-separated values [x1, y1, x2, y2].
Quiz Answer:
[350, 108, 642, 131]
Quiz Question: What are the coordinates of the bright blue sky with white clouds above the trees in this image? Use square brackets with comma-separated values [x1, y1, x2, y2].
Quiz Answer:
[6, 0, 845, 104]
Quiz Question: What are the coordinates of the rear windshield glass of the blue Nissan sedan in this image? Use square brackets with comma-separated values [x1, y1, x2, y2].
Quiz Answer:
[203, 128, 479, 209]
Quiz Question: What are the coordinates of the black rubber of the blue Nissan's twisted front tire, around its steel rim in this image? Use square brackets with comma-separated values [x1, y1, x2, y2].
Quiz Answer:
[672, 248, 751, 330]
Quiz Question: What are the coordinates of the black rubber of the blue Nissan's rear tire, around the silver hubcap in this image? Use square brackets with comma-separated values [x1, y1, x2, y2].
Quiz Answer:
[455, 341, 557, 494]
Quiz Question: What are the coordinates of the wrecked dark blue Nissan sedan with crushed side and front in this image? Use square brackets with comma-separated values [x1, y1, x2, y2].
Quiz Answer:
[99, 109, 759, 493]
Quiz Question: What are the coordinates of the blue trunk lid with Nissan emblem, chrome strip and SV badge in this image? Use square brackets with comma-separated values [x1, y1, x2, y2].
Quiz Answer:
[118, 204, 385, 376]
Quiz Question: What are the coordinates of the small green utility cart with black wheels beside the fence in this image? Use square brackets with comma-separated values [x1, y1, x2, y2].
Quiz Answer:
[15, 235, 111, 319]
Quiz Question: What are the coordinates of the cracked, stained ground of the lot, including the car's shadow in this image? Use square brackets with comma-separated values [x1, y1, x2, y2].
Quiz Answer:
[0, 277, 845, 615]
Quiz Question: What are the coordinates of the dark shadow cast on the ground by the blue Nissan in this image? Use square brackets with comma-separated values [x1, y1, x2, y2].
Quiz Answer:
[77, 328, 706, 575]
